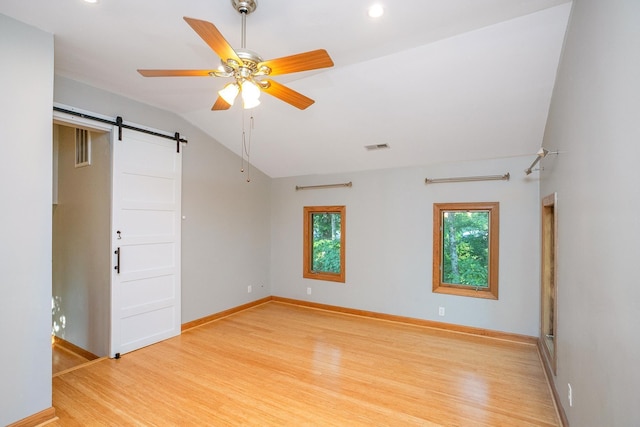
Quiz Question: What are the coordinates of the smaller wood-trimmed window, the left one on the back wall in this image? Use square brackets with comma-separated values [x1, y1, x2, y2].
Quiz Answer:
[302, 206, 346, 283]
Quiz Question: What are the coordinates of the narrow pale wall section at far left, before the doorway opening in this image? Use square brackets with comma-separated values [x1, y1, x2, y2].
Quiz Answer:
[0, 14, 53, 425]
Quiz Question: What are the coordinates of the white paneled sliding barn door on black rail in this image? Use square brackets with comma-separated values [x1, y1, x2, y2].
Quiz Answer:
[110, 127, 182, 357]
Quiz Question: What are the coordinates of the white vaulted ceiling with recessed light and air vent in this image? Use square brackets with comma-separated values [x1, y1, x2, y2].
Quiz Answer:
[0, 0, 571, 177]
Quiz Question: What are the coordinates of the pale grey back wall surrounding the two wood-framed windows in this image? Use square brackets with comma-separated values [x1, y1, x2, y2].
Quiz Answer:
[271, 157, 540, 336]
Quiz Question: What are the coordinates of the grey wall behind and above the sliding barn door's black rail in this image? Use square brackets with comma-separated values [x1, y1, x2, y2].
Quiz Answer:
[54, 76, 271, 323]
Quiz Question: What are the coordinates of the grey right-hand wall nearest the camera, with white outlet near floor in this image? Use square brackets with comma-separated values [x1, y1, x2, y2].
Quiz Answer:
[541, 0, 640, 427]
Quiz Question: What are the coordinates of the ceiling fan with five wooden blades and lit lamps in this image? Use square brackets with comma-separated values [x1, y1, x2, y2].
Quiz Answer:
[138, 0, 333, 110]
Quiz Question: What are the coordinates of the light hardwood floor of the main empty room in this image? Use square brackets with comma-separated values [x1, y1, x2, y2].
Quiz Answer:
[49, 302, 559, 426]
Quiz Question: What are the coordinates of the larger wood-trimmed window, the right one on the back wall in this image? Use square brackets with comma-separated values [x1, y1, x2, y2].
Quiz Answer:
[433, 202, 500, 299]
